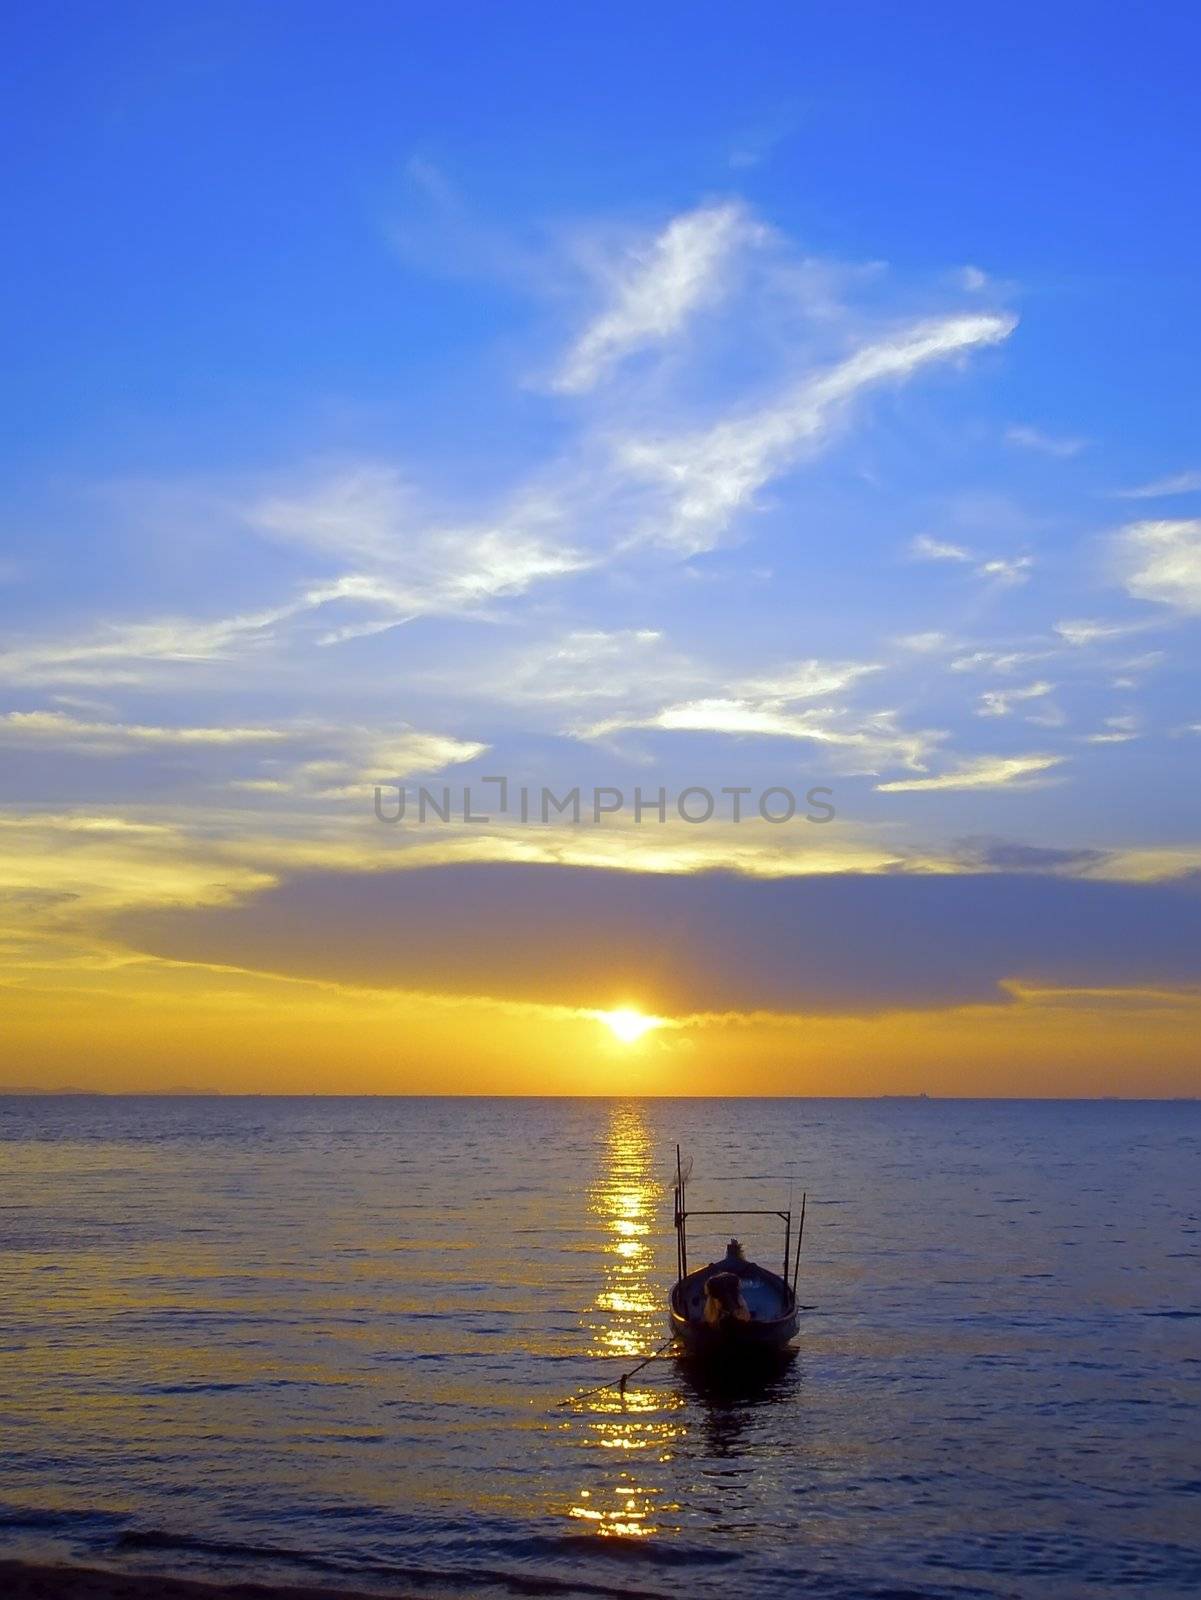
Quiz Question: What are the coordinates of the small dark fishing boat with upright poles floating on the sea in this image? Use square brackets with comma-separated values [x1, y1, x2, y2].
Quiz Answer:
[668, 1146, 808, 1365]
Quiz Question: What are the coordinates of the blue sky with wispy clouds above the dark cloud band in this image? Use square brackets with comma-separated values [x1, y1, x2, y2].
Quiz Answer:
[0, 3, 1201, 1094]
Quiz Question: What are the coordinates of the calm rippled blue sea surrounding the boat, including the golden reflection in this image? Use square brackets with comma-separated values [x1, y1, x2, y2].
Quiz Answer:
[0, 1098, 1201, 1600]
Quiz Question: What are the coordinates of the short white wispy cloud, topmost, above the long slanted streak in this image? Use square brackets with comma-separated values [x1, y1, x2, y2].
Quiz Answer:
[553, 203, 764, 394]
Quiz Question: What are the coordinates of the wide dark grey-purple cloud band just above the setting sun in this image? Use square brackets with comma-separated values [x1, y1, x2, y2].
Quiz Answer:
[117, 862, 1201, 1014]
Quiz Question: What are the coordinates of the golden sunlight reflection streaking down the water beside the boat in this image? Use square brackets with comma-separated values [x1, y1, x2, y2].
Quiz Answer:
[568, 1102, 684, 1538]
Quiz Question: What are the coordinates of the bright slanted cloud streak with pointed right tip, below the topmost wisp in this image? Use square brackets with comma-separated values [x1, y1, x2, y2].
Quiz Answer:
[617, 314, 1017, 555]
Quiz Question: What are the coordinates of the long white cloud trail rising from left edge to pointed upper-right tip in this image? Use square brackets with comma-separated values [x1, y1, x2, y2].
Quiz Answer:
[0, 292, 1014, 685]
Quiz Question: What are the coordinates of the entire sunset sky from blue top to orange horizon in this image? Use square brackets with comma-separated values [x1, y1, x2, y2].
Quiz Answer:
[0, 0, 1201, 1096]
